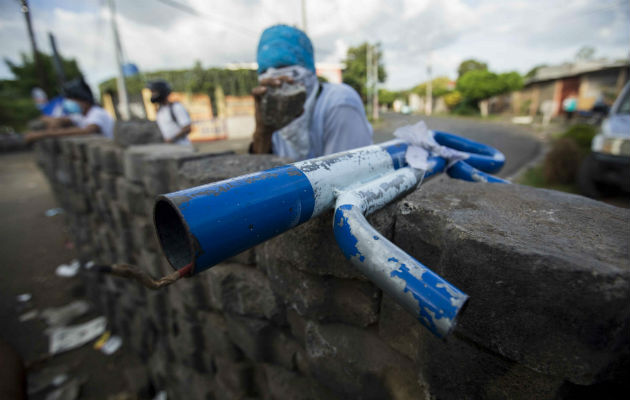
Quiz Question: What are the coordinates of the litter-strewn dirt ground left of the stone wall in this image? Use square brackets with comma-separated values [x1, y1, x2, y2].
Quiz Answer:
[0, 152, 144, 400]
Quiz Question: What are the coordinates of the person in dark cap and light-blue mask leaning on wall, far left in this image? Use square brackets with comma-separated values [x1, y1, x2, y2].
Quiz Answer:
[25, 78, 114, 142]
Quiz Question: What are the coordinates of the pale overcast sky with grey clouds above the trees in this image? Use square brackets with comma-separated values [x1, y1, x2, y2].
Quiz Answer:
[0, 0, 630, 89]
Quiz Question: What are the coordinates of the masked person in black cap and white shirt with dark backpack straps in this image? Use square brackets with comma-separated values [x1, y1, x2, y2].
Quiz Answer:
[147, 80, 191, 145]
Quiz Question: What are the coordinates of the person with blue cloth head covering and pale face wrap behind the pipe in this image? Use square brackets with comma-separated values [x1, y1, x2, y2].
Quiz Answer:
[250, 25, 372, 160]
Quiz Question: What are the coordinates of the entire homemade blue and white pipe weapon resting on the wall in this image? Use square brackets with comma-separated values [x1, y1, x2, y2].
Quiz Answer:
[154, 132, 503, 337]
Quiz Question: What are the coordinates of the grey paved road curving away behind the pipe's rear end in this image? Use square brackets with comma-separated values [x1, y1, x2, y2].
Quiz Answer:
[374, 113, 541, 177]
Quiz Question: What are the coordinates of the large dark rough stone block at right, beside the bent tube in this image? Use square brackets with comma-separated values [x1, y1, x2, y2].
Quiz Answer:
[395, 181, 630, 384]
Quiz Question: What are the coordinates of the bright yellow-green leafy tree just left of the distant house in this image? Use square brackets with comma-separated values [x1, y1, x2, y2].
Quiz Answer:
[457, 70, 523, 101]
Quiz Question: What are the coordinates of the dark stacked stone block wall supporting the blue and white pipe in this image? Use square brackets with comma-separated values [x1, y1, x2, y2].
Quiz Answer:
[36, 136, 630, 400]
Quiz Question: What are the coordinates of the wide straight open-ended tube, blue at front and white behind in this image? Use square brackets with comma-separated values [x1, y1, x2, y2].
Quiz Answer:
[154, 141, 406, 274]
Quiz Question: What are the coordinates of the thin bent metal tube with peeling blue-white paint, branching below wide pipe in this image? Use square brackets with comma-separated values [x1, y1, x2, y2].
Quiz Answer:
[333, 168, 468, 337]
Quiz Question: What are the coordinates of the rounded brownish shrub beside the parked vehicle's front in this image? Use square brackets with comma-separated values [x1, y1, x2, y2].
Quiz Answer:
[543, 137, 590, 184]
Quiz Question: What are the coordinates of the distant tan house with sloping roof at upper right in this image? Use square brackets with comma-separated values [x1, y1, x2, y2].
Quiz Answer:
[496, 60, 630, 117]
